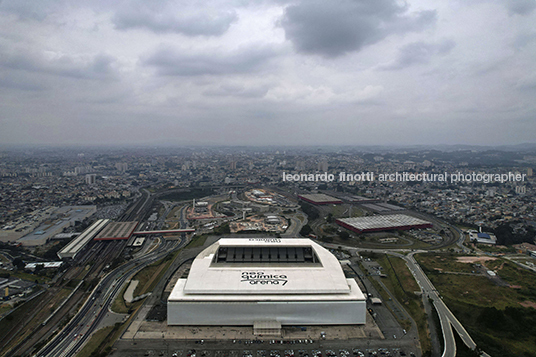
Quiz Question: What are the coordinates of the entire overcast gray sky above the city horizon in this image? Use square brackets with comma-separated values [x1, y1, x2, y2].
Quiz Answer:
[0, 0, 536, 145]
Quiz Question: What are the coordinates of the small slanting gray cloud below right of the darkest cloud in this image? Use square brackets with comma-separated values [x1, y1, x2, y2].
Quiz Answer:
[381, 40, 455, 70]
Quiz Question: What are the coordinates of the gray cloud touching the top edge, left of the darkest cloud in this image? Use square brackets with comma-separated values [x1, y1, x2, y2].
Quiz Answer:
[112, 1, 238, 36]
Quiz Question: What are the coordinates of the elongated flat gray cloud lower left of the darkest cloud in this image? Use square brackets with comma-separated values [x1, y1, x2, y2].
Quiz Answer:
[143, 47, 278, 76]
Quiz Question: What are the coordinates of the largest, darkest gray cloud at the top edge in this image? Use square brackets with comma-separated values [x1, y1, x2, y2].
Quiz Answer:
[281, 0, 436, 57]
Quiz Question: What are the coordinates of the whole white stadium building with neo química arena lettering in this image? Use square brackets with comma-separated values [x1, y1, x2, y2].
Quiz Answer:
[167, 238, 366, 326]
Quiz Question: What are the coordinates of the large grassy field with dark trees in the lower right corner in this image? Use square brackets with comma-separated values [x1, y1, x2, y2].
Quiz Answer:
[416, 254, 536, 356]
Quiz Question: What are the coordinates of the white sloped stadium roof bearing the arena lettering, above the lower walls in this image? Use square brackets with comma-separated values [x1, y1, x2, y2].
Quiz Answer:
[176, 238, 361, 294]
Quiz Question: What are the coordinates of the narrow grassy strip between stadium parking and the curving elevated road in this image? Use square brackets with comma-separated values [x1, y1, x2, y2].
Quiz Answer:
[378, 255, 431, 354]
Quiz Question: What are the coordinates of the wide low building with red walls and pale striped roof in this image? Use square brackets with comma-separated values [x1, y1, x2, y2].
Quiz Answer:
[335, 214, 433, 233]
